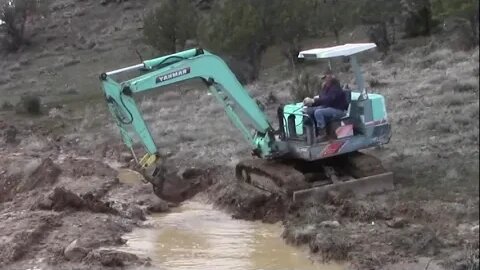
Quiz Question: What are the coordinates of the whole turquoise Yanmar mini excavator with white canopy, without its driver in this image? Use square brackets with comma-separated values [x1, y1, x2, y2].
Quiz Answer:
[100, 43, 394, 202]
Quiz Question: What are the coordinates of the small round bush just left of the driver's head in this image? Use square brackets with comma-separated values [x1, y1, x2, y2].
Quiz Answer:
[290, 72, 322, 102]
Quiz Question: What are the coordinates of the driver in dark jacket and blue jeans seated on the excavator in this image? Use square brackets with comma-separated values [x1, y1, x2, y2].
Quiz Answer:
[303, 70, 348, 137]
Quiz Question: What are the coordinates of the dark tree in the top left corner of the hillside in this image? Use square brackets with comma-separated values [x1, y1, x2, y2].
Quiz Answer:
[0, 0, 48, 51]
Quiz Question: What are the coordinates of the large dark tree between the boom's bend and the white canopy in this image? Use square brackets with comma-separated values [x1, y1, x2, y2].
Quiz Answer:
[200, 0, 322, 77]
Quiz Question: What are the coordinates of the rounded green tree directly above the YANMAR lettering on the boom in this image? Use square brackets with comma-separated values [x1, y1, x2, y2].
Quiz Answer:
[143, 0, 198, 54]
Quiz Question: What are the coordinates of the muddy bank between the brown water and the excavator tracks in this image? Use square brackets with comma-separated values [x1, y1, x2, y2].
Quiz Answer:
[211, 178, 476, 269]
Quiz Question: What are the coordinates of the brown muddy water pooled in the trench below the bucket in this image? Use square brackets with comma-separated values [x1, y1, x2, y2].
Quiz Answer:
[116, 201, 343, 270]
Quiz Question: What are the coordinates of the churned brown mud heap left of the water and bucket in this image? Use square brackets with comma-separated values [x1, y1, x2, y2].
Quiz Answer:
[0, 123, 159, 269]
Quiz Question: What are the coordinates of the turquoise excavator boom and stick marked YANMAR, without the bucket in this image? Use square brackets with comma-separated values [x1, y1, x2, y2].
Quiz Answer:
[100, 49, 281, 170]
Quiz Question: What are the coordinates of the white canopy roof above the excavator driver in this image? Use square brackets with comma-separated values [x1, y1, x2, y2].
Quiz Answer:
[298, 43, 377, 59]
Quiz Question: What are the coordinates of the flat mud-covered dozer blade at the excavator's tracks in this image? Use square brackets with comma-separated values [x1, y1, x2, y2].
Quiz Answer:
[293, 172, 394, 202]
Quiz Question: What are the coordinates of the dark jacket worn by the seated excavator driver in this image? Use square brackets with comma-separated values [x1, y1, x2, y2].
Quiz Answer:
[312, 80, 348, 111]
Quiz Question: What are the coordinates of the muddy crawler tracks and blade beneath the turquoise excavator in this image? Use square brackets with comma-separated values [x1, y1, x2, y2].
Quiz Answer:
[235, 152, 394, 201]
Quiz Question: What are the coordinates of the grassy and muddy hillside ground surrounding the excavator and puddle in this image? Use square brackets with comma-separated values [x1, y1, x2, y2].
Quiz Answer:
[0, 0, 479, 269]
